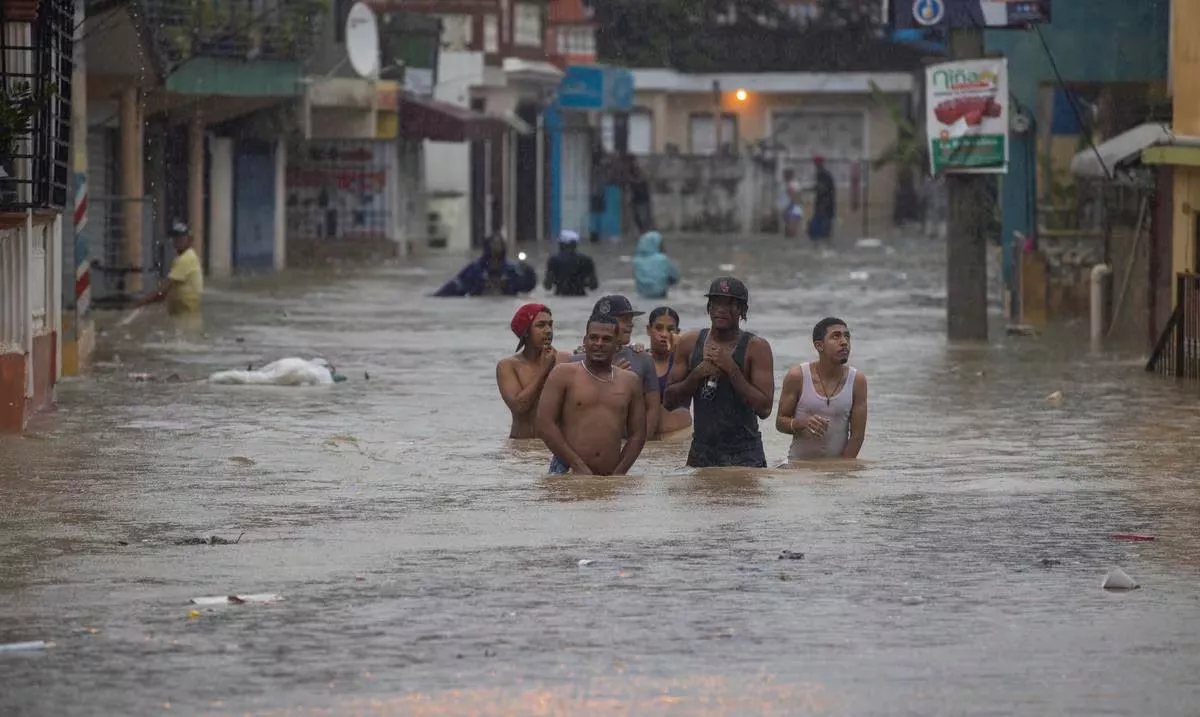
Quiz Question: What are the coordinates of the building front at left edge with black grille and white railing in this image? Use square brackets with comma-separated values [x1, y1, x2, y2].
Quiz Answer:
[0, 0, 76, 432]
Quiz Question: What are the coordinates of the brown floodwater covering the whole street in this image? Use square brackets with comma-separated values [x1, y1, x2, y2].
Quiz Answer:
[0, 237, 1200, 717]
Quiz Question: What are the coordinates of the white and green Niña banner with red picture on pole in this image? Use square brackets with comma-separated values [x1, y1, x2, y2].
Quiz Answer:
[925, 58, 1009, 175]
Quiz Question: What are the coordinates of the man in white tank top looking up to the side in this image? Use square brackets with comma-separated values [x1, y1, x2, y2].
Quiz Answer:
[775, 317, 866, 462]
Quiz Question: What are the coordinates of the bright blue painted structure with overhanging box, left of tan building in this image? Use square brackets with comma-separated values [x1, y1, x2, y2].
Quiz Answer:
[542, 65, 634, 237]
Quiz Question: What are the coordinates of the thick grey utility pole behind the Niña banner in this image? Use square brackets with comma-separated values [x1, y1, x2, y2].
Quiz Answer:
[946, 28, 993, 341]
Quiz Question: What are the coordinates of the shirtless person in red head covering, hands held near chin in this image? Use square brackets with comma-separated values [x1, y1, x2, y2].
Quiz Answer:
[496, 303, 570, 438]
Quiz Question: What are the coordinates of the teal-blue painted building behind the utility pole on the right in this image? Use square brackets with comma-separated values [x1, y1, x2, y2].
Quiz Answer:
[986, 0, 1170, 311]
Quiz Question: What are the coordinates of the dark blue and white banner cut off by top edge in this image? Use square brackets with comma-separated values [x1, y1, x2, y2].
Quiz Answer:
[883, 0, 1050, 30]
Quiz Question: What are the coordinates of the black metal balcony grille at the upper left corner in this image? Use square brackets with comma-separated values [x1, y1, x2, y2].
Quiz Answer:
[0, 0, 74, 211]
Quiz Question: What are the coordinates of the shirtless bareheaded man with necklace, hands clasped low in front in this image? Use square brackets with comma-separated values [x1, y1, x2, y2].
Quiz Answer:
[538, 315, 646, 476]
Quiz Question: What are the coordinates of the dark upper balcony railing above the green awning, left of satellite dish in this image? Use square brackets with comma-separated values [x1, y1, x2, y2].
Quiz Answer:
[142, 0, 330, 73]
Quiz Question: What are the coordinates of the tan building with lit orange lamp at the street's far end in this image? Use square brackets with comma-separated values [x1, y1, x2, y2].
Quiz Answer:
[624, 70, 914, 235]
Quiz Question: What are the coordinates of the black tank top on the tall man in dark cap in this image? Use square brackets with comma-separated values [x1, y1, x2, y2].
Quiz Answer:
[688, 329, 767, 468]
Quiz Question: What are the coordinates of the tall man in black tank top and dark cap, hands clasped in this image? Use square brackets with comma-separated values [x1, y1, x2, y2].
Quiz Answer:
[662, 277, 775, 468]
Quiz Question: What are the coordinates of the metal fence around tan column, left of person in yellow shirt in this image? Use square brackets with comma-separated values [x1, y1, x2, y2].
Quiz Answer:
[88, 197, 160, 308]
